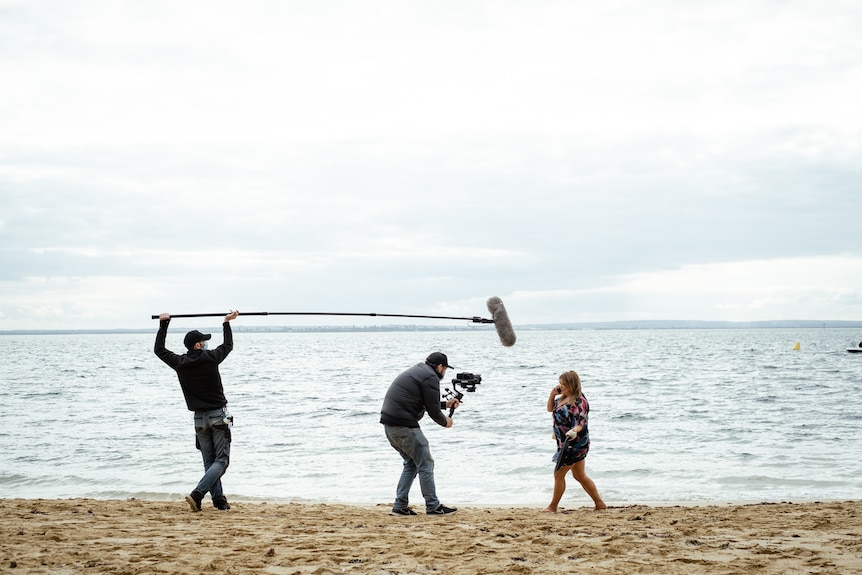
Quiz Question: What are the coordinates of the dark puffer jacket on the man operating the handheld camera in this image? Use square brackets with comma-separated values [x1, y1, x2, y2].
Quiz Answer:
[380, 363, 446, 427]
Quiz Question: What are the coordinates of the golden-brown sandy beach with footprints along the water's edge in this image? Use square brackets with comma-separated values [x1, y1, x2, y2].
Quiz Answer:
[0, 499, 862, 575]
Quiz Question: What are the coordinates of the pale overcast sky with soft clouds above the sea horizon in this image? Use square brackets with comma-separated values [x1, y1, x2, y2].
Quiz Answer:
[0, 0, 862, 330]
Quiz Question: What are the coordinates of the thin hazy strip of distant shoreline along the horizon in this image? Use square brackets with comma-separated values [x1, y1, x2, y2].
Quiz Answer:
[0, 320, 862, 335]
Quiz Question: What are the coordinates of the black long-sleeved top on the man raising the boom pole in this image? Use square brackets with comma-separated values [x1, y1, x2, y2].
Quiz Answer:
[153, 320, 233, 411]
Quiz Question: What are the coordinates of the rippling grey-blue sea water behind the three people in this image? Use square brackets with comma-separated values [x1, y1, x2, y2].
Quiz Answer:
[0, 328, 862, 507]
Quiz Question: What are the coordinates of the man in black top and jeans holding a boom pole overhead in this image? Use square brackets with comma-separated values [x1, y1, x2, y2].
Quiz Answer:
[153, 311, 239, 511]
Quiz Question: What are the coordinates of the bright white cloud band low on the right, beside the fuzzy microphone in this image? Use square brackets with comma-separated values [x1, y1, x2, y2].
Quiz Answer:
[506, 256, 862, 323]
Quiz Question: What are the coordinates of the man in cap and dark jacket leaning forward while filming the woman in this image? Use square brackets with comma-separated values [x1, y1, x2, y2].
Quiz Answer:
[380, 351, 460, 515]
